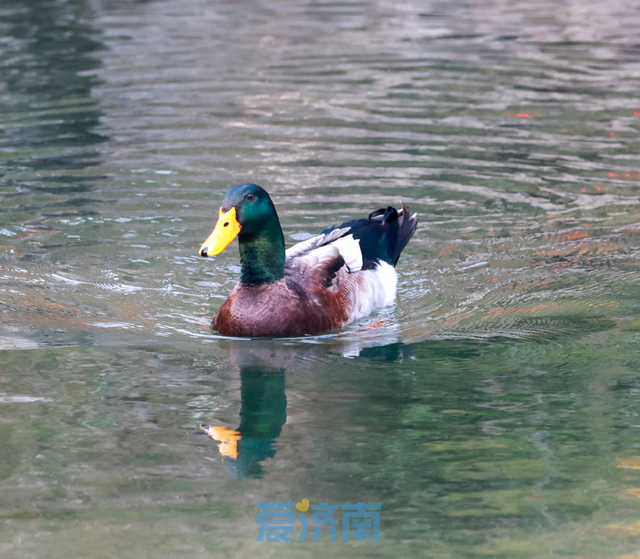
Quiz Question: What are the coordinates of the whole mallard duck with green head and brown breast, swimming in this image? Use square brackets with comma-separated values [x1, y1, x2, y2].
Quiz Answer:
[200, 184, 418, 337]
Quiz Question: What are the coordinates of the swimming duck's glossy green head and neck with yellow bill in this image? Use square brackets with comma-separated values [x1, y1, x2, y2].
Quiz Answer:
[200, 184, 285, 283]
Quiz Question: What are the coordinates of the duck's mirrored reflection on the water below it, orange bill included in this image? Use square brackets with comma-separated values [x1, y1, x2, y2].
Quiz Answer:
[200, 334, 411, 478]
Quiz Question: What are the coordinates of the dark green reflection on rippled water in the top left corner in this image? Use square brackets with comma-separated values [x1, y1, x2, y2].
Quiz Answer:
[0, 0, 105, 200]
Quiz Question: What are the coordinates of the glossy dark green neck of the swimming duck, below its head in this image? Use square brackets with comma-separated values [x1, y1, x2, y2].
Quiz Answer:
[238, 218, 285, 285]
